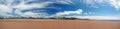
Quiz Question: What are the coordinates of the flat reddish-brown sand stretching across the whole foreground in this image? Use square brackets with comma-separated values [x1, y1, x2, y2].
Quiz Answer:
[0, 19, 120, 29]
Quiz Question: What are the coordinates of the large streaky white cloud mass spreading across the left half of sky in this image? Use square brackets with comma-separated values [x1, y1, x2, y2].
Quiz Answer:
[0, 0, 73, 17]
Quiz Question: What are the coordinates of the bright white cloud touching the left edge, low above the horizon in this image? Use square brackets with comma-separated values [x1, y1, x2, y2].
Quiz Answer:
[0, 4, 12, 16]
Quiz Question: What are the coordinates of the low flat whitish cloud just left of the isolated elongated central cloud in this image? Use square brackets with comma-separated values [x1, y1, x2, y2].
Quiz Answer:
[21, 12, 48, 18]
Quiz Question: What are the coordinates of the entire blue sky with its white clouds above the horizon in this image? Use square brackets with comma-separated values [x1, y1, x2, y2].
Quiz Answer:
[0, 0, 120, 19]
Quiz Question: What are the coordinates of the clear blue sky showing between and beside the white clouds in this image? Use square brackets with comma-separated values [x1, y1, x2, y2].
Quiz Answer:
[0, 0, 120, 16]
